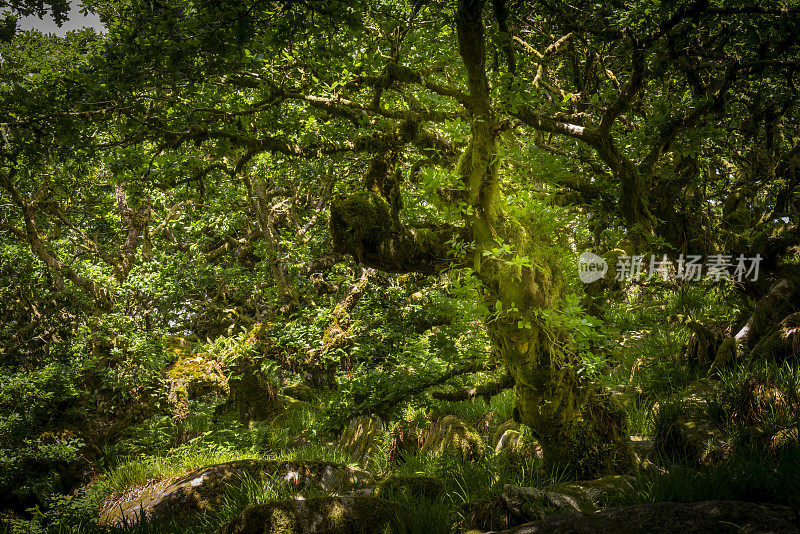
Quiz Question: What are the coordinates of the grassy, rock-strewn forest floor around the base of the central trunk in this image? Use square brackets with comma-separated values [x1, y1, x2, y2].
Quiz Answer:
[0, 284, 800, 533]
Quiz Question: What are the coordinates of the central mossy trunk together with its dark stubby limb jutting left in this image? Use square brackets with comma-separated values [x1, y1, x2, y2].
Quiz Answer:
[330, 0, 634, 477]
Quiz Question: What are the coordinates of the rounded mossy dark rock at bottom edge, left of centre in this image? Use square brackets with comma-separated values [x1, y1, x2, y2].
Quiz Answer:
[219, 495, 399, 534]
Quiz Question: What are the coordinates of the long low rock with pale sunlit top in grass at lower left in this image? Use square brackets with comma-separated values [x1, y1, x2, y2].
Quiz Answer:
[100, 460, 375, 525]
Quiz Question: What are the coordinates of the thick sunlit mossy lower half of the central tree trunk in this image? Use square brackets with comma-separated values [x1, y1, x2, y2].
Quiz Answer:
[472, 181, 634, 478]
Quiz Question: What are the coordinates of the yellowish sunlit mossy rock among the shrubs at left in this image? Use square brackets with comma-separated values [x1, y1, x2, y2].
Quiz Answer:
[166, 350, 230, 421]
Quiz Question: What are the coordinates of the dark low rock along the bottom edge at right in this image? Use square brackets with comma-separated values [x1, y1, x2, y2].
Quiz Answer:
[482, 501, 800, 534]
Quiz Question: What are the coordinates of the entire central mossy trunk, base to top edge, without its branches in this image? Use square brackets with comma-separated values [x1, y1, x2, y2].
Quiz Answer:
[456, 0, 633, 477]
